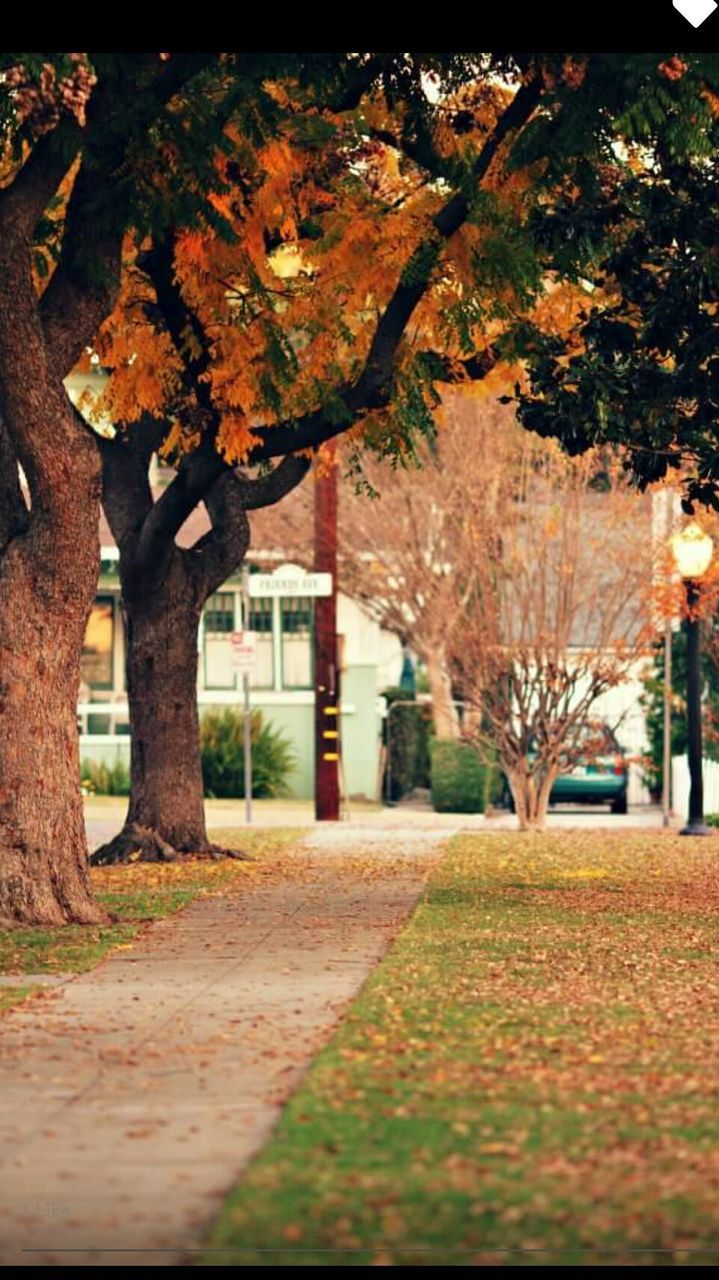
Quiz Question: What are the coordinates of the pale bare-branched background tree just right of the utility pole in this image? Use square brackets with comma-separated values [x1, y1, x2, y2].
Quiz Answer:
[339, 381, 519, 737]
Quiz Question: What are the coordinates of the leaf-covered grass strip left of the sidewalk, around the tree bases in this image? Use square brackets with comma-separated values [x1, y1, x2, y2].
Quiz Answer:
[0, 827, 302, 977]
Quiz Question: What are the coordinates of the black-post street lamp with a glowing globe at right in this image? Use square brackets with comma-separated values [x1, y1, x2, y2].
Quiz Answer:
[672, 521, 714, 836]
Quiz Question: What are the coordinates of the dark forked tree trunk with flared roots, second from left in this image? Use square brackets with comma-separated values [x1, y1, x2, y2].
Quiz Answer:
[92, 445, 304, 864]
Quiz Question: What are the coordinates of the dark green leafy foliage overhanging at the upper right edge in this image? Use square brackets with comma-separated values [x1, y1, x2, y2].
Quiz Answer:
[513, 55, 719, 512]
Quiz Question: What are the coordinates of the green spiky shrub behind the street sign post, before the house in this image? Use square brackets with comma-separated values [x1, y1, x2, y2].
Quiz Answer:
[200, 707, 294, 800]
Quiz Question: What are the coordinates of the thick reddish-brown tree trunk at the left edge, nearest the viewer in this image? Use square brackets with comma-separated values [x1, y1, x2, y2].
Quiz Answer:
[0, 225, 106, 924]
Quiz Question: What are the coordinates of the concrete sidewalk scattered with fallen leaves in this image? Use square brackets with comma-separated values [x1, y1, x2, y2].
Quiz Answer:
[0, 824, 450, 1266]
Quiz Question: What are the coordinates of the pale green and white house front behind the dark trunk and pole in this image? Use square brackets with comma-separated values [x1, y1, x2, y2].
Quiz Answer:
[78, 550, 402, 800]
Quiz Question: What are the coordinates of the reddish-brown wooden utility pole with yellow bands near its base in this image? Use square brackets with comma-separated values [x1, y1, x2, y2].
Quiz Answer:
[315, 440, 342, 822]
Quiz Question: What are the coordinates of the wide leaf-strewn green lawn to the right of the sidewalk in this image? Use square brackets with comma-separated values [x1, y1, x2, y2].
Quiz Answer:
[202, 832, 719, 1266]
